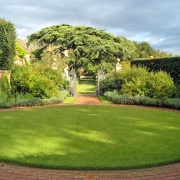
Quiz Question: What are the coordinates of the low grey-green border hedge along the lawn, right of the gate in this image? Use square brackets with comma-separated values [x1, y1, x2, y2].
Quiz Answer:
[104, 92, 180, 109]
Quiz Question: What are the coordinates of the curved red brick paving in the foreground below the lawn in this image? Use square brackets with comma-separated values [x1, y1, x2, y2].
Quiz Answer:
[0, 160, 180, 180]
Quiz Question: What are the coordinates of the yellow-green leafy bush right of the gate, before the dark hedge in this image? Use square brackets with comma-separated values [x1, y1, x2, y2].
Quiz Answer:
[101, 67, 177, 99]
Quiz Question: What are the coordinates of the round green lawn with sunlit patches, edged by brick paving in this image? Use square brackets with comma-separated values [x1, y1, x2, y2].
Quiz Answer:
[0, 106, 180, 169]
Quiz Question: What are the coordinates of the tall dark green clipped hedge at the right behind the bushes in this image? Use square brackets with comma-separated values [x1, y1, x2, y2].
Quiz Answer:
[131, 56, 180, 85]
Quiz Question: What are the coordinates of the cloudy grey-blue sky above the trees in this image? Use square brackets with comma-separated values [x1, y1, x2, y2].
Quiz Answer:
[0, 0, 180, 55]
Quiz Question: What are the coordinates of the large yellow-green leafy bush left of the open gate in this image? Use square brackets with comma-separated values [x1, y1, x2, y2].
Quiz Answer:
[11, 63, 65, 98]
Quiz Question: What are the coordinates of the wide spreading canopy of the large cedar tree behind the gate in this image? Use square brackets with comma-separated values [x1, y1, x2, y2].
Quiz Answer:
[28, 24, 172, 72]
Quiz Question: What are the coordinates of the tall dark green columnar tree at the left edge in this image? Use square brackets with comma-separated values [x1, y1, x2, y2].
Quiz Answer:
[0, 18, 16, 70]
